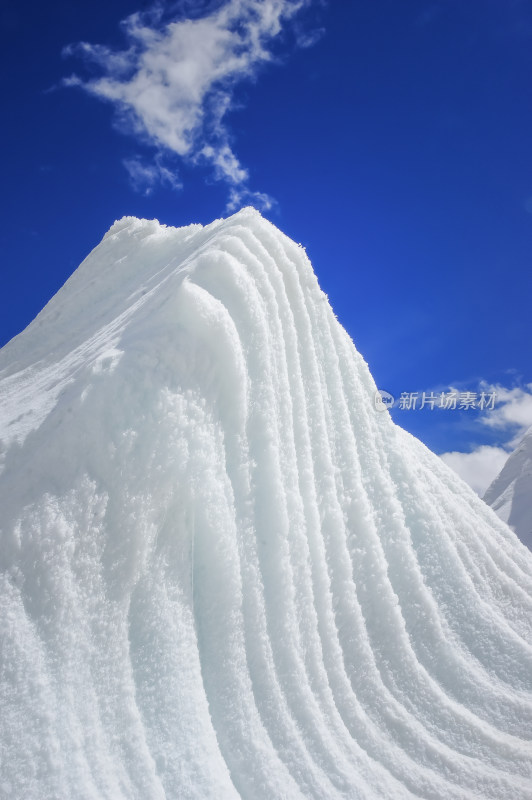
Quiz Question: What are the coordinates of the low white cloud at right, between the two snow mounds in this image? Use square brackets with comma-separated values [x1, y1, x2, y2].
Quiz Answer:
[441, 381, 532, 496]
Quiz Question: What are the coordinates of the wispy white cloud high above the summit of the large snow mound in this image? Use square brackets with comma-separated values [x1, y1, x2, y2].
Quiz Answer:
[63, 0, 321, 208]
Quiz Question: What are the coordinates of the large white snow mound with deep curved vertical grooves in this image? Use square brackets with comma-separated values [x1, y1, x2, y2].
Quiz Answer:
[0, 209, 532, 800]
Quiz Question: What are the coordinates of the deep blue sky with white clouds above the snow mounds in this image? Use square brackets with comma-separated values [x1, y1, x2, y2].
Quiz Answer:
[0, 0, 532, 490]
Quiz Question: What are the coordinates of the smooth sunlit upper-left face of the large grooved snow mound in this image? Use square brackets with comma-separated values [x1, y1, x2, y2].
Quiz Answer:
[0, 208, 274, 456]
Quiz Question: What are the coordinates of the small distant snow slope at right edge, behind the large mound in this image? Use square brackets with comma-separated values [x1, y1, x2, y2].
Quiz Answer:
[484, 428, 532, 550]
